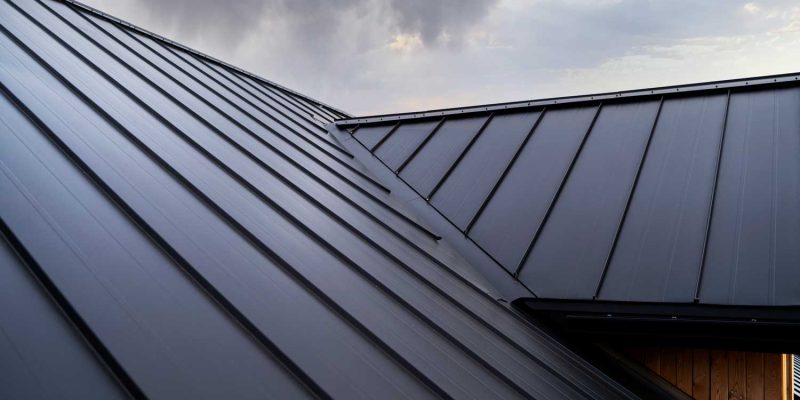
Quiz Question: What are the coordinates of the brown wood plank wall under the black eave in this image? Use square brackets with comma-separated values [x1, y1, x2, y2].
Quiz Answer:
[623, 347, 792, 400]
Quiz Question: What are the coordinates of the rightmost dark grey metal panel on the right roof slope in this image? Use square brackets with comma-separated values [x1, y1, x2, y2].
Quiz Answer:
[700, 88, 800, 305]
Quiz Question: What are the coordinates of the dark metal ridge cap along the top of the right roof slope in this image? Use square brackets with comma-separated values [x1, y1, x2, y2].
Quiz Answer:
[338, 71, 800, 127]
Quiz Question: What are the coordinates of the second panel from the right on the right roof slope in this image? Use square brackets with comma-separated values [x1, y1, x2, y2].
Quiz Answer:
[600, 94, 727, 302]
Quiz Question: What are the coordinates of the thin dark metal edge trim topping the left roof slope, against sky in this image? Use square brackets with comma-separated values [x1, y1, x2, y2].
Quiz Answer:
[55, 0, 352, 117]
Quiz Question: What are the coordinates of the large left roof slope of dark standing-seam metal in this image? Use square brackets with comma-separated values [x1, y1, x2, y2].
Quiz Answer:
[0, 0, 632, 399]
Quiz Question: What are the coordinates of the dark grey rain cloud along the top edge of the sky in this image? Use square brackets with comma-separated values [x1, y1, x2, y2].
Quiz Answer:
[125, 0, 498, 49]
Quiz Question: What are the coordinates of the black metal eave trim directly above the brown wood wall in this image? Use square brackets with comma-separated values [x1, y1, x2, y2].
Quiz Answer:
[515, 299, 800, 354]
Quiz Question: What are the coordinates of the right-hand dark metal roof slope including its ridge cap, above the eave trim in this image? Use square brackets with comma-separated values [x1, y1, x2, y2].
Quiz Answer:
[337, 74, 800, 306]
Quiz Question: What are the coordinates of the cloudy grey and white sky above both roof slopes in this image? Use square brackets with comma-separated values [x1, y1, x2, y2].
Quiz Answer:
[78, 0, 800, 115]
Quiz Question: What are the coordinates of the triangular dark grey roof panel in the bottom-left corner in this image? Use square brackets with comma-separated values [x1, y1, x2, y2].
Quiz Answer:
[0, 228, 127, 399]
